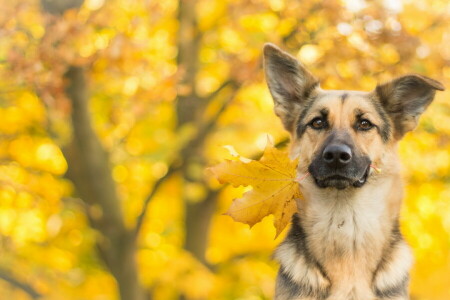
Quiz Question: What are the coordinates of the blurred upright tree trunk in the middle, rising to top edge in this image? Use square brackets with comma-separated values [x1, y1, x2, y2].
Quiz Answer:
[177, 0, 215, 263]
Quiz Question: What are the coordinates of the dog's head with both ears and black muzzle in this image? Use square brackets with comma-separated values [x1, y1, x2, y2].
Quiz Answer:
[264, 44, 444, 189]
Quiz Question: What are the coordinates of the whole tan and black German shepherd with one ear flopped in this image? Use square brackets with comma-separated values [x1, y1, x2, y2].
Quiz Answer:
[264, 44, 444, 300]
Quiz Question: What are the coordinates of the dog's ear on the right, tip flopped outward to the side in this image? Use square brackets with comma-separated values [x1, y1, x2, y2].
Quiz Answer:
[375, 74, 445, 139]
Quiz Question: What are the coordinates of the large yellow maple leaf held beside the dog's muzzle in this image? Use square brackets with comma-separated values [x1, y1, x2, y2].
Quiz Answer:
[209, 143, 301, 238]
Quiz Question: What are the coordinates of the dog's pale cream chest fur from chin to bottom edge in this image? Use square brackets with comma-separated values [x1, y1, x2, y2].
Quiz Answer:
[299, 180, 392, 299]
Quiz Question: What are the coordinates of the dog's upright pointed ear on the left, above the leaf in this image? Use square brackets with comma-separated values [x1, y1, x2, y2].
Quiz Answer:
[264, 44, 319, 132]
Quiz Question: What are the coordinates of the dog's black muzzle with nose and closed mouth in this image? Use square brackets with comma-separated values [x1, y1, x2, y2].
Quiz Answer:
[309, 143, 370, 190]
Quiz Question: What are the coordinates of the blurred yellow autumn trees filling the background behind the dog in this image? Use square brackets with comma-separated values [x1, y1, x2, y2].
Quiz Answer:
[0, 0, 450, 300]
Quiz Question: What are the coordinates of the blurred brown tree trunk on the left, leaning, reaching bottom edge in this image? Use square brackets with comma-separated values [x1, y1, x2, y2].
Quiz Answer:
[64, 66, 144, 300]
